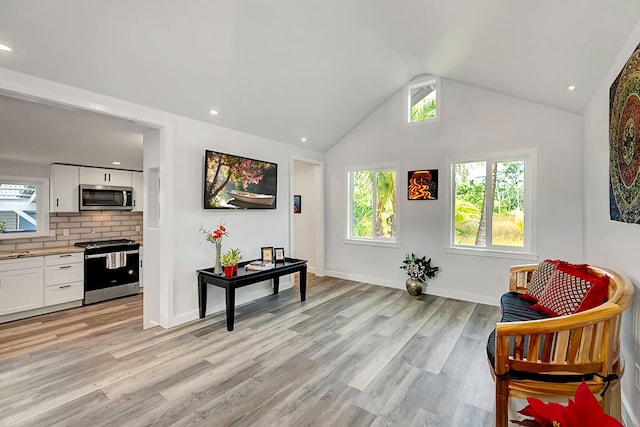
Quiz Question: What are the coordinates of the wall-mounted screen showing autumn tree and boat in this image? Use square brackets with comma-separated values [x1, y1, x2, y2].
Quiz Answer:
[204, 150, 278, 209]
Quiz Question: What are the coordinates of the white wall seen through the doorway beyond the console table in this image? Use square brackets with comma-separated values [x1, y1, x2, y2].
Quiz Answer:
[292, 160, 318, 273]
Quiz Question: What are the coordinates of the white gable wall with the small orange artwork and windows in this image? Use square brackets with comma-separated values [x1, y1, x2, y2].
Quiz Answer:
[326, 79, 583, 304]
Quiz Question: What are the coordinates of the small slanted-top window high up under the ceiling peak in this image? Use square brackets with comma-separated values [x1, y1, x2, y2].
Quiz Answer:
[404, 76, 441, 125]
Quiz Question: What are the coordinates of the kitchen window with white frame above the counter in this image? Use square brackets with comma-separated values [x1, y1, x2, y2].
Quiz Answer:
[0, 176, 49, 240]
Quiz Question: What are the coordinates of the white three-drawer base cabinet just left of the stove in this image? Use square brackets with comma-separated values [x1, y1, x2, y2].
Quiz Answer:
[44, 252, 84, 306]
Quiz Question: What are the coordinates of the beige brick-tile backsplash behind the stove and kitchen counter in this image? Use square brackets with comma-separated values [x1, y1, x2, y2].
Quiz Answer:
[0, 211, 142, 252]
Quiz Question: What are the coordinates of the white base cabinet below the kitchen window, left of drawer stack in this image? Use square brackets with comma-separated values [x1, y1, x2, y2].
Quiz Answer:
[0, 257, 44, 315]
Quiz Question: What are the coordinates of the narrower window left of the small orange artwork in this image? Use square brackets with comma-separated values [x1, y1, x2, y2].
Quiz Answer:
[348, 168, 397, 243]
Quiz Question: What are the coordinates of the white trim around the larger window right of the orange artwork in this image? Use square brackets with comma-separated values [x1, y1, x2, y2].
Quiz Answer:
[446, 149, 538, 260]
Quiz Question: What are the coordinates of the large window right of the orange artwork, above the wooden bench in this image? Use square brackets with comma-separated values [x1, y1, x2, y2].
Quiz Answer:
[451, 154, 535, 253]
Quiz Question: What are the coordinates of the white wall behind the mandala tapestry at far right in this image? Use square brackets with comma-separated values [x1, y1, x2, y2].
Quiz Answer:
[584, 18, 640, 427]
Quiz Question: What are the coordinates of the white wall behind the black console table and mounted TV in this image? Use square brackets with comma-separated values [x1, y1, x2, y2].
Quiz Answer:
[172, 117, 323, 322]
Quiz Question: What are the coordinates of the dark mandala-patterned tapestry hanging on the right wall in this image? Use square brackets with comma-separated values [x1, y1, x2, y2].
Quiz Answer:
[609, 45, 640, 224]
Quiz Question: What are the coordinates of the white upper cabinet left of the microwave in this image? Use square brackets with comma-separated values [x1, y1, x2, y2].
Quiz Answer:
[49, 164, 79, 212]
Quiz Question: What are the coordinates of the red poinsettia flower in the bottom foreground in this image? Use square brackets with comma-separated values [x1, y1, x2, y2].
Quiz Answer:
[511, 381, 623, 427]
